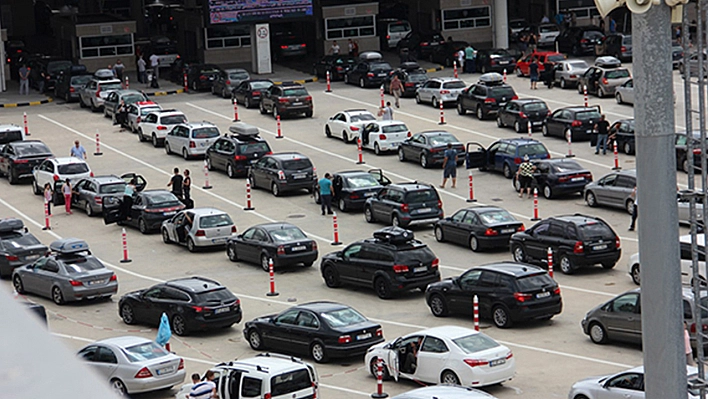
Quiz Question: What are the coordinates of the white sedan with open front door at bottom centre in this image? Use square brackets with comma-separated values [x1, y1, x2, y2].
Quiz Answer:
[365, 326, 516, 387]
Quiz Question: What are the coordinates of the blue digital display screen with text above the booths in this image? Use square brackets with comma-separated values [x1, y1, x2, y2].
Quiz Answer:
[209, 0, 312, 24]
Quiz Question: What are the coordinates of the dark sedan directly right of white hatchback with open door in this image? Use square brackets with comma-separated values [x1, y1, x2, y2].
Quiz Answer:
[226, 223, 318, 271]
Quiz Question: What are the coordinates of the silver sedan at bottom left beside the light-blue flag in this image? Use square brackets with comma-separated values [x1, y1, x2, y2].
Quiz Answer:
[78, 336, 185, 396]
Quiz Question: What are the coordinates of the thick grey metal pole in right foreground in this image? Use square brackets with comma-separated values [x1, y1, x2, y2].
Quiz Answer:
[632, 2, 684, 399]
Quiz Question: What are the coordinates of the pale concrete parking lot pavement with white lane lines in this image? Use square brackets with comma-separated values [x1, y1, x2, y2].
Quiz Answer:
[0, 61, 686, 399]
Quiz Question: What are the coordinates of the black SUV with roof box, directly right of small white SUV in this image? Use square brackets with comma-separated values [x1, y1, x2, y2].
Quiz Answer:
[205, 131, 273, 179]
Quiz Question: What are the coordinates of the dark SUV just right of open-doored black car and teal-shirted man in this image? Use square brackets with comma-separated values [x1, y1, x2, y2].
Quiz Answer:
[364, 182, 444, 227]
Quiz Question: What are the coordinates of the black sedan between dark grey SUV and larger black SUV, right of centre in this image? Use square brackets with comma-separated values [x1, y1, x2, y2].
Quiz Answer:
[435, 205, 524, 252]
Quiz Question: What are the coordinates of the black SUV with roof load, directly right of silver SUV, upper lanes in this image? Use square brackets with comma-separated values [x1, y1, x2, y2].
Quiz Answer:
[457, 72, 519, 120]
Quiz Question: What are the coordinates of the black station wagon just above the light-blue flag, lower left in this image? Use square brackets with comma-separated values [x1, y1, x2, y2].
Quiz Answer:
[118, 276, 243, 336]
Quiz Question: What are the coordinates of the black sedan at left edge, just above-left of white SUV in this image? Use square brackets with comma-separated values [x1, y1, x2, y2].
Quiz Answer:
[0, 140, 54, 184]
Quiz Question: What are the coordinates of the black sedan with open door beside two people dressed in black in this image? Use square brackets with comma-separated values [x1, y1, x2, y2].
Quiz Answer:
[103, 190, 184, 234]
